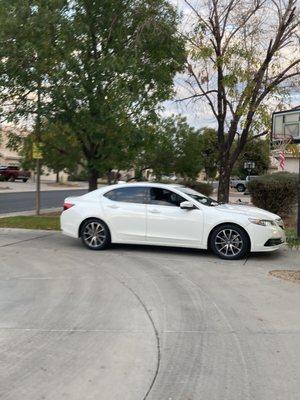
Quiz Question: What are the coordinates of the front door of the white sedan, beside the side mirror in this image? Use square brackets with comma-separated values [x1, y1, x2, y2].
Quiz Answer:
[146, 187, 203, 247]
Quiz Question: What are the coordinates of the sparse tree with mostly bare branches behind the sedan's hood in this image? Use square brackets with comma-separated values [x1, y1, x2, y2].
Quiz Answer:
[179, 0, 300, 202]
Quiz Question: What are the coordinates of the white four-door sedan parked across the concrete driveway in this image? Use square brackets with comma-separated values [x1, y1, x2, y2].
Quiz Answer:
[61, 183, 285, 260]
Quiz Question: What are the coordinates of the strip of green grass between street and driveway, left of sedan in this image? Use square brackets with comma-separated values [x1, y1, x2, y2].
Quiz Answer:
[0, 215, 60, 231]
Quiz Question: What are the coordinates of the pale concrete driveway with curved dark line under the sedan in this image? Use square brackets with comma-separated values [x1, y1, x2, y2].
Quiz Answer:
[0, 229, 300, 400]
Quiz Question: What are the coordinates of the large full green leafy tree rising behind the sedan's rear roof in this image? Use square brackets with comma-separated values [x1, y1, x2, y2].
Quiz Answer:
[46, 0, 185, 190]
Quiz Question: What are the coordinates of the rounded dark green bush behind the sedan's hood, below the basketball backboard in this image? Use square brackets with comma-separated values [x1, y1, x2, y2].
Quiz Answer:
[247, 172, 298, 217]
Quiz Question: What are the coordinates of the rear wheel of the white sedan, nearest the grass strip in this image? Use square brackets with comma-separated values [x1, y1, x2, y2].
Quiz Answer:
[80, 218, 111, 250]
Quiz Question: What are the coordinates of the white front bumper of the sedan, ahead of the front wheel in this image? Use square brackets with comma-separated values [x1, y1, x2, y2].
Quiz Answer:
[247, 223, 286, 251]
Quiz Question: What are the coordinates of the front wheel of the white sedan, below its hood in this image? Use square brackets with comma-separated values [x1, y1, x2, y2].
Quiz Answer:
[209, 224, 250, 260]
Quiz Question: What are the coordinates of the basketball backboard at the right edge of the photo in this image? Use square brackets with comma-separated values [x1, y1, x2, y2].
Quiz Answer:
[272, 107, 300, 143]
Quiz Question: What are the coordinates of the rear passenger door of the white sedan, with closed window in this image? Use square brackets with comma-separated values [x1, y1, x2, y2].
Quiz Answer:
[102, 186, 146, 243]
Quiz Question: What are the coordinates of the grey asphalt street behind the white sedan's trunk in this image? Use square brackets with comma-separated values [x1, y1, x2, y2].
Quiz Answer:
[0, 189, 87, 214]
